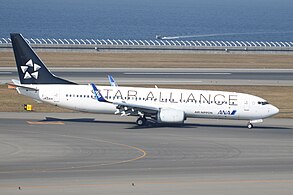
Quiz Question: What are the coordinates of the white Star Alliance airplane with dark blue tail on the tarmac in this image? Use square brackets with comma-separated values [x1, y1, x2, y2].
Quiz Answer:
[10, 33, 279, 128]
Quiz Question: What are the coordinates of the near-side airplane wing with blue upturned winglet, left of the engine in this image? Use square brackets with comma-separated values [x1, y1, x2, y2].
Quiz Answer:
[91, 83, 160, 116]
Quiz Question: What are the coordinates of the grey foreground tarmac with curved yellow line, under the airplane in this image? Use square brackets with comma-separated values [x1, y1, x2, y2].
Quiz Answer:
[0, 113, 293, 194]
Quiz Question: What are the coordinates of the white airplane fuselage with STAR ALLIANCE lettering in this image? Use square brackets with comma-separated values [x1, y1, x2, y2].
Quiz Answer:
[18, 84, 279, 120]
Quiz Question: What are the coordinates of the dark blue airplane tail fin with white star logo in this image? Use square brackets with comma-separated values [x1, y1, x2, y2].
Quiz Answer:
[10, 33, 76, 84]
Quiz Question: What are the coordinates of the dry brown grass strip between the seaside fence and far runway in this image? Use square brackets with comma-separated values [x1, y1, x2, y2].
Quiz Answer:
[0, 49, 293, 69]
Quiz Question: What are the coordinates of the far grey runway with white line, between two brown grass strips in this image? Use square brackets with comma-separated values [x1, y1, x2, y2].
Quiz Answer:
[0, 67, 293, 86]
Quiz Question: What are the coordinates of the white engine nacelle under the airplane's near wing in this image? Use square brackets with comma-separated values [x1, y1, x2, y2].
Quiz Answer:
[157, 108, 185, 123]
